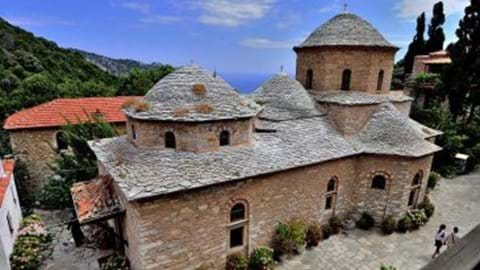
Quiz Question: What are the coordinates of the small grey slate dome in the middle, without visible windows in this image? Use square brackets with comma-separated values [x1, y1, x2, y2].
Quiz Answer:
[250, 73, 320, 121]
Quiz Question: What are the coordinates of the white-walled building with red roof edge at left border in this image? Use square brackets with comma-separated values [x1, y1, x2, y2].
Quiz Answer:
[0, 159, 22, 269]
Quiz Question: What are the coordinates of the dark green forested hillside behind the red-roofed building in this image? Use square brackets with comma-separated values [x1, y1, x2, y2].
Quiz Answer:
[0, 18, 173, 155]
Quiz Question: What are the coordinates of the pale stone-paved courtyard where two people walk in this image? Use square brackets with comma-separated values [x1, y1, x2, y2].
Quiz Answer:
[276, 171, 480, 270]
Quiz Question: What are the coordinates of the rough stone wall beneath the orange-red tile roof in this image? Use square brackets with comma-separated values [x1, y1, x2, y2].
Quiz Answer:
[10, 124, 125, 192]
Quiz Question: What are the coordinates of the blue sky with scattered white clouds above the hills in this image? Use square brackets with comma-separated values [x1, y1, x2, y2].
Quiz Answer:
[0, 0, 469, 74]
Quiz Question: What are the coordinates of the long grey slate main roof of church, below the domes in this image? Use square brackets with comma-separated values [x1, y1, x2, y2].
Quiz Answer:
[89, 105, 440, 200]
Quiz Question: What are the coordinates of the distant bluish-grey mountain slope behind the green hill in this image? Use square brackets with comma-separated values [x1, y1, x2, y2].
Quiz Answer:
[71, 49, 162, 76]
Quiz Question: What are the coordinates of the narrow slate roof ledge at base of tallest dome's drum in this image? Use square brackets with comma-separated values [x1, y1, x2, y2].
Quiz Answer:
[310, 91, 413, 106]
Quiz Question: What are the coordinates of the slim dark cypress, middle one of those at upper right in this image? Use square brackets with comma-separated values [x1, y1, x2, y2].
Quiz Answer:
[426, 2, 445, 53]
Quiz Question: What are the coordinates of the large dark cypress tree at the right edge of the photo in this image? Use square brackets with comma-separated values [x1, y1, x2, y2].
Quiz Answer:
[443, 0, 480, 119]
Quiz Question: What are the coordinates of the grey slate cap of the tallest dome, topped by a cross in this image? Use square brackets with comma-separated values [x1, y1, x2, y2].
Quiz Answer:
[295, 13, 396, 49]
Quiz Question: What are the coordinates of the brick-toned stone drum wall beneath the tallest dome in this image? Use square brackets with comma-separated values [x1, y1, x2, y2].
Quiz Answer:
[296, 47, 395, 93]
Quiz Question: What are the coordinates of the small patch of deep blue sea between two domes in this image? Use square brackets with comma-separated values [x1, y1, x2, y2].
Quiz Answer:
[219, 73, 273, 94]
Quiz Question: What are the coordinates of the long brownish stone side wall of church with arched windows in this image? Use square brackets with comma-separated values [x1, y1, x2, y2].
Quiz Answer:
[124, 153, 432, 270]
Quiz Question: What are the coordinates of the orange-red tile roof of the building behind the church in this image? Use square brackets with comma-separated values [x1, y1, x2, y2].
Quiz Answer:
[4, 96, 143, 130]
